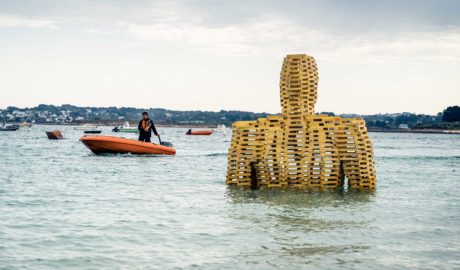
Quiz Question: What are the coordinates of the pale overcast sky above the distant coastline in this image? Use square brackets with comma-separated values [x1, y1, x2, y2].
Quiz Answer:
[0, 0, 460, 114]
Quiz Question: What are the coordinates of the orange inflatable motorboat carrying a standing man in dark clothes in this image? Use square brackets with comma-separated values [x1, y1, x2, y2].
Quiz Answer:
[80, 135, 176, 155]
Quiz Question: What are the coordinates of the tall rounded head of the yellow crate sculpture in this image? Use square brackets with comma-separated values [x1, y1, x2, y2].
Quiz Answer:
[280, 54, 319, 117]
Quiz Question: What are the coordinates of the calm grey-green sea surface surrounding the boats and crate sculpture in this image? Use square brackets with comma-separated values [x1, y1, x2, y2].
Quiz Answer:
[0, 126, 460, 269]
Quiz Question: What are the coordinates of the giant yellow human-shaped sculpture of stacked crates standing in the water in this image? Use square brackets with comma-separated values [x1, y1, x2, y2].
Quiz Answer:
[227, 54, 376, 189]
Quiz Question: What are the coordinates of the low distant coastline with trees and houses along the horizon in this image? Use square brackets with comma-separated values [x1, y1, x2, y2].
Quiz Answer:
[0, 104, 460, 134]
